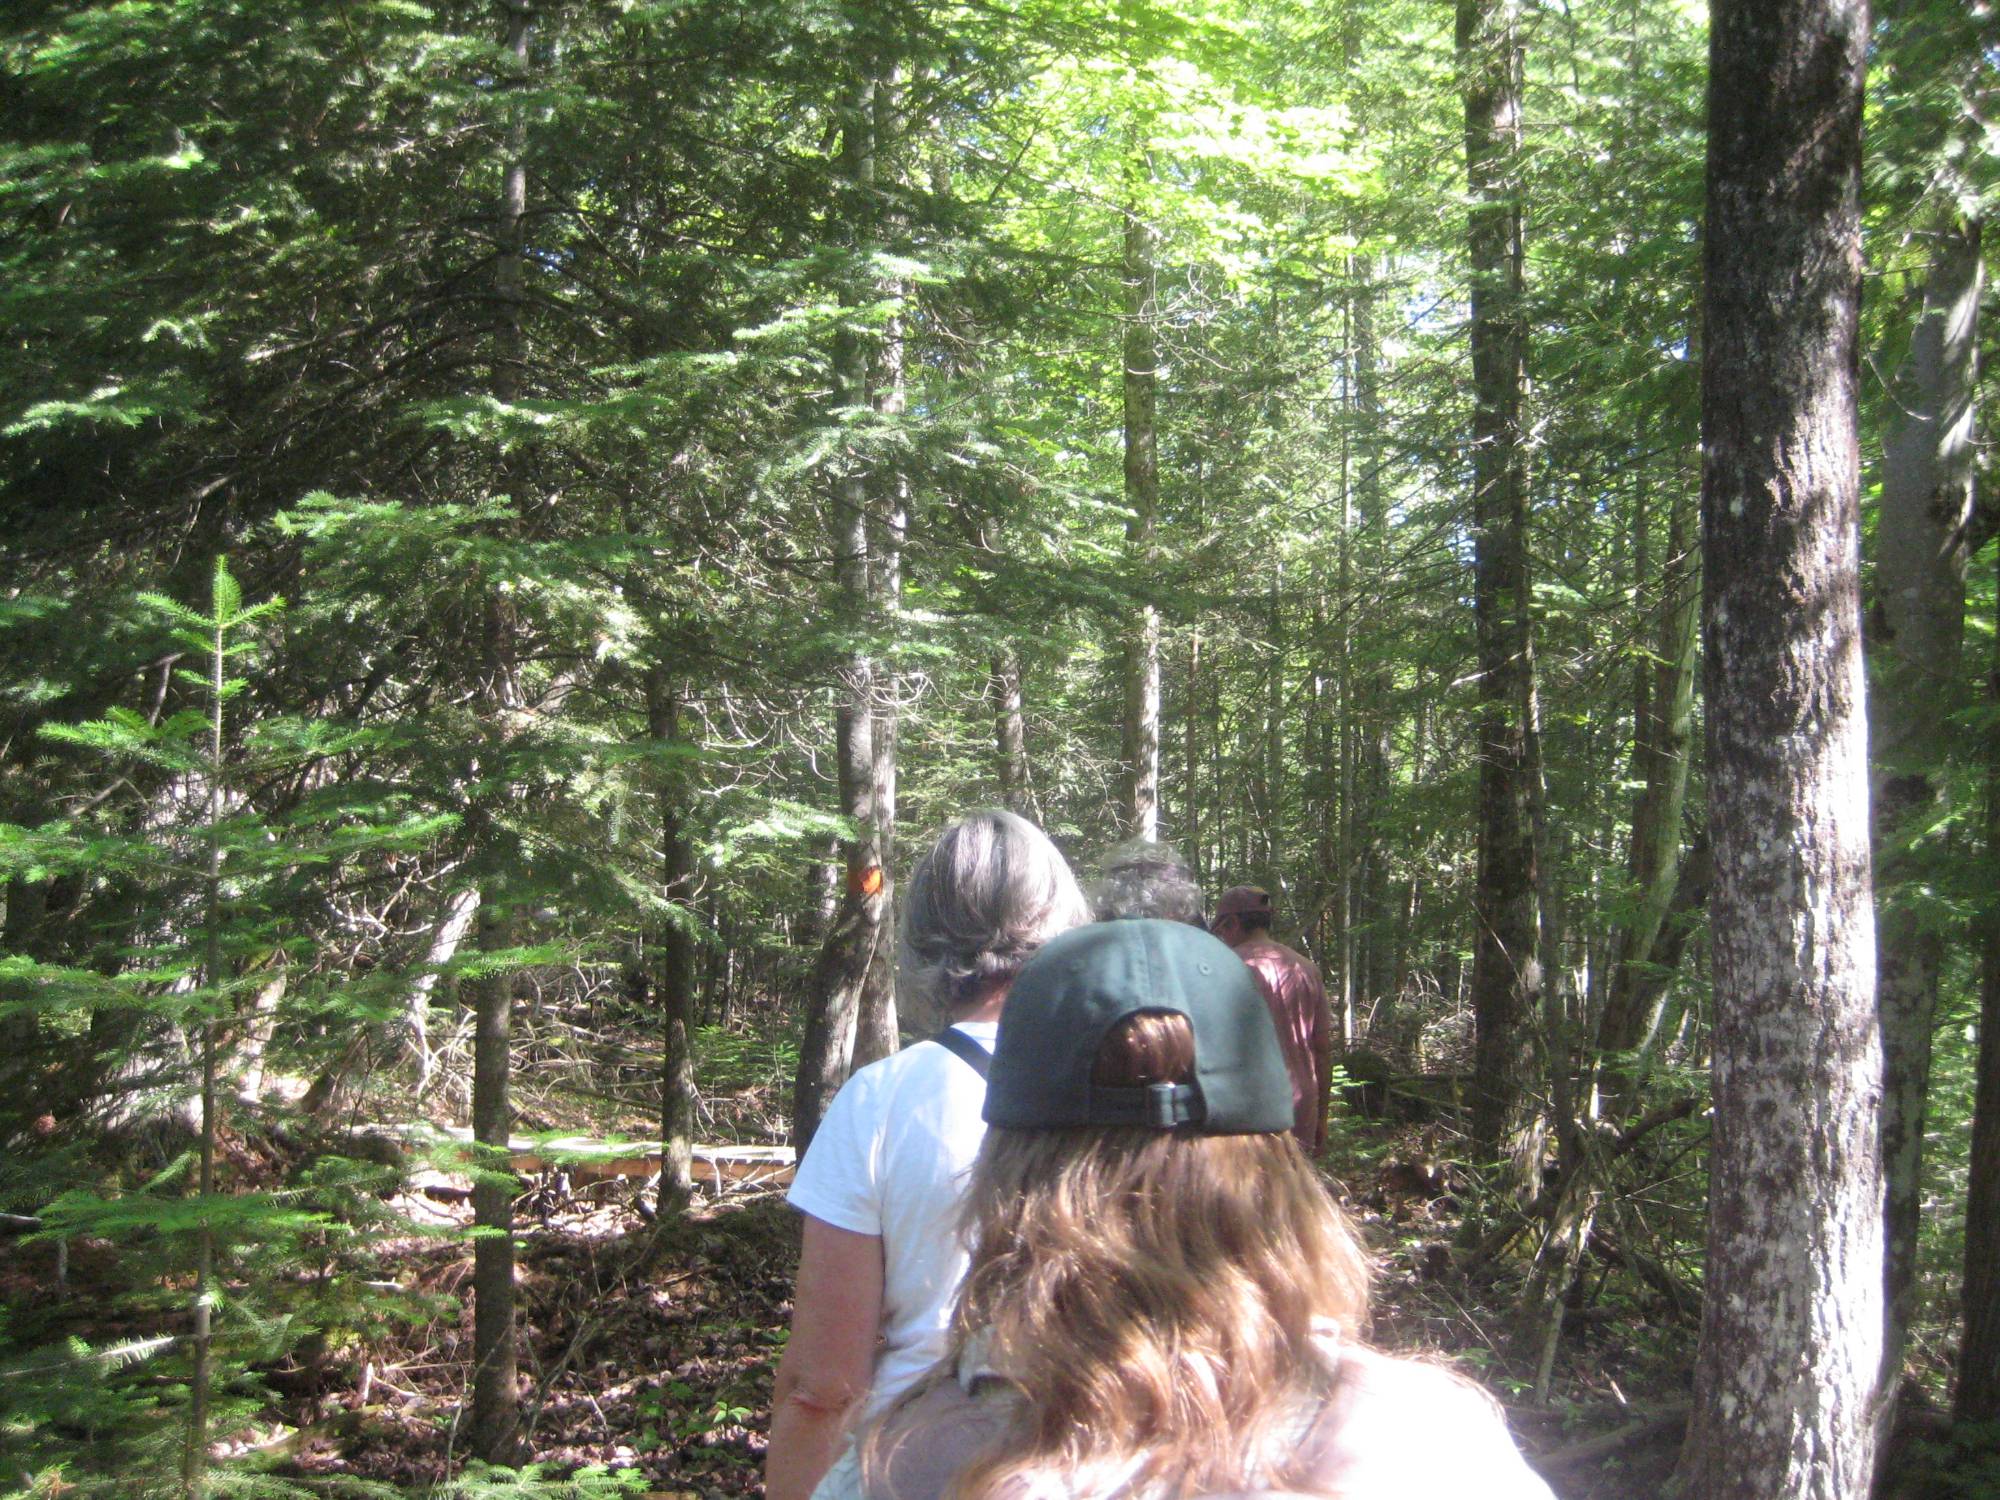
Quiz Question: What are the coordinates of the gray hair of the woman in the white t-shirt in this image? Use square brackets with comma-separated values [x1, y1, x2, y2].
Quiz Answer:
[898, 808, 1090, 1016]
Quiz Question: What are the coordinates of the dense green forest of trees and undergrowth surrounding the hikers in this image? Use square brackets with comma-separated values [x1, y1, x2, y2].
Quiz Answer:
[0, 0, 2000, 1500]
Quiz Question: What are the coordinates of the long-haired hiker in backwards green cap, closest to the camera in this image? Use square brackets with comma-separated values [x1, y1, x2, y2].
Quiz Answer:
[814, 920, 1550, 1500]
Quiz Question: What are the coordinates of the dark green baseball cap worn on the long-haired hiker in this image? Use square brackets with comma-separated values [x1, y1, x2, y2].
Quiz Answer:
[986, 918, 1292, 1136]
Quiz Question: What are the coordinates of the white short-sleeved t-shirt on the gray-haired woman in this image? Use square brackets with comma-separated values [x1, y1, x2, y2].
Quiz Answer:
[786, 1020, 1000, 1416]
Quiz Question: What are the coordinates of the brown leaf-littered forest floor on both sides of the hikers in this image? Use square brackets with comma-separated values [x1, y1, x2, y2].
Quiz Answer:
[0, 1048, 2000, 1500]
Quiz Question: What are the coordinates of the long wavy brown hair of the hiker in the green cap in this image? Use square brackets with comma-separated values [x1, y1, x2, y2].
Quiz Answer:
[864, 1012, 1368, 1500]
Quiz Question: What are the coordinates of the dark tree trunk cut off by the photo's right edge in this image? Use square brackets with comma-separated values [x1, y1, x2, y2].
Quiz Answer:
[1952, 536, 2000, 1422]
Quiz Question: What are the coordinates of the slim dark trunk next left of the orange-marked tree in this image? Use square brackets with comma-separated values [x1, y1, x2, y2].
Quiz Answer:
[646, 666, 696, 1210]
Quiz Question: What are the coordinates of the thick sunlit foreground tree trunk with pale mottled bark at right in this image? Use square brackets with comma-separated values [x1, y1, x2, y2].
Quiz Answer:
[1680, 0, 1882, 1500]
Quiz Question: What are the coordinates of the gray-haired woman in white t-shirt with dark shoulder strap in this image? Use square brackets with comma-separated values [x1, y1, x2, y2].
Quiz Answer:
[764, 808, 1090, 1500]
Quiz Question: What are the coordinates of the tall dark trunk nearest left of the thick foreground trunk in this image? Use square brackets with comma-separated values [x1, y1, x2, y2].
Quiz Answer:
[1456, 0, 1542, 1192]
